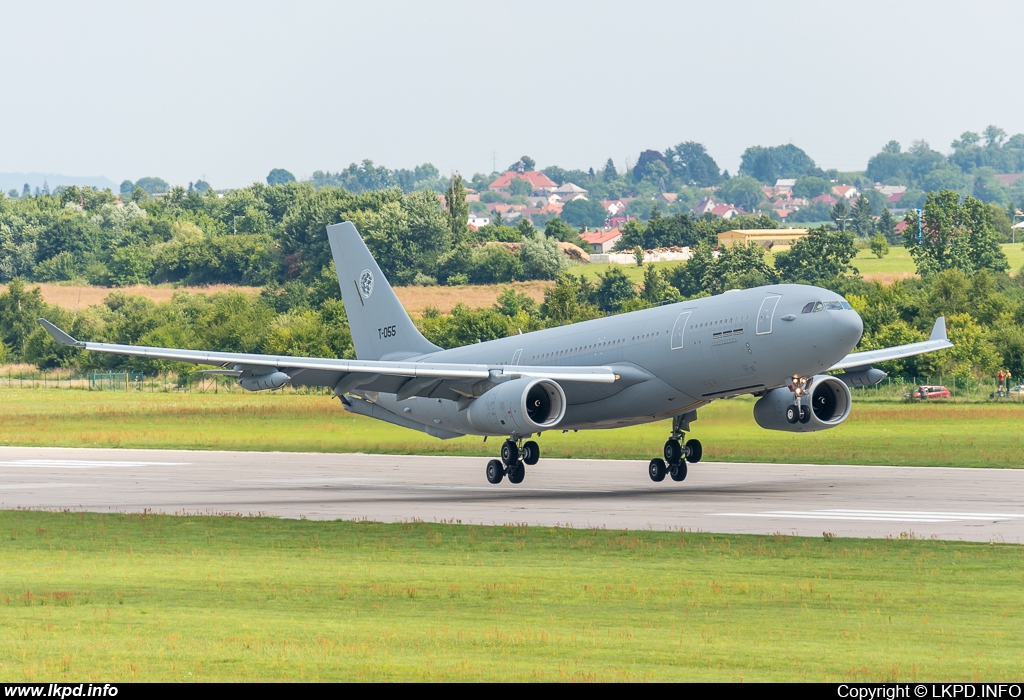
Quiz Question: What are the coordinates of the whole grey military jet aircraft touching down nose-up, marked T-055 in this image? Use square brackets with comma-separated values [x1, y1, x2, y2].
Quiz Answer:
[39, 222, 952, 484]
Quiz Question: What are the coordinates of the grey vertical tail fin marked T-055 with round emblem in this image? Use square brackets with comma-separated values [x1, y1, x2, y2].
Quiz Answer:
[327, 221, 440, 360]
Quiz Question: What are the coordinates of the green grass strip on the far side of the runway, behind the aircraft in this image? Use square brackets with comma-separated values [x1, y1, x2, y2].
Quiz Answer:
[6, 389, 1024, 468]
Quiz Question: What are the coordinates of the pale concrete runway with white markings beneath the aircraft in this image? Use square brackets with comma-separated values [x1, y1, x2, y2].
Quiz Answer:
[0, 447, 1024, 543]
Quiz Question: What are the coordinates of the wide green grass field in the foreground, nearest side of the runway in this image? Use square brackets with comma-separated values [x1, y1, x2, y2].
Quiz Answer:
[0, 512, 1024, 682]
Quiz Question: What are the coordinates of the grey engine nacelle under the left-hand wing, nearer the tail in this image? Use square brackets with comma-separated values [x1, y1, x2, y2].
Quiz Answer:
[466, 377, 565, 435]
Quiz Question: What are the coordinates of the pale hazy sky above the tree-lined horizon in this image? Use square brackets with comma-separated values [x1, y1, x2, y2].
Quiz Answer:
[0, 0, 1024, 187]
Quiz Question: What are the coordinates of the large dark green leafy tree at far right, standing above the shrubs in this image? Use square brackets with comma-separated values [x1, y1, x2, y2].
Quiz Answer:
[903, 189, 1009, 277]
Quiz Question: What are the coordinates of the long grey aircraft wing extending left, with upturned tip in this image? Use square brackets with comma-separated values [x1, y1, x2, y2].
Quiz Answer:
[39, 318, 620, 384]
